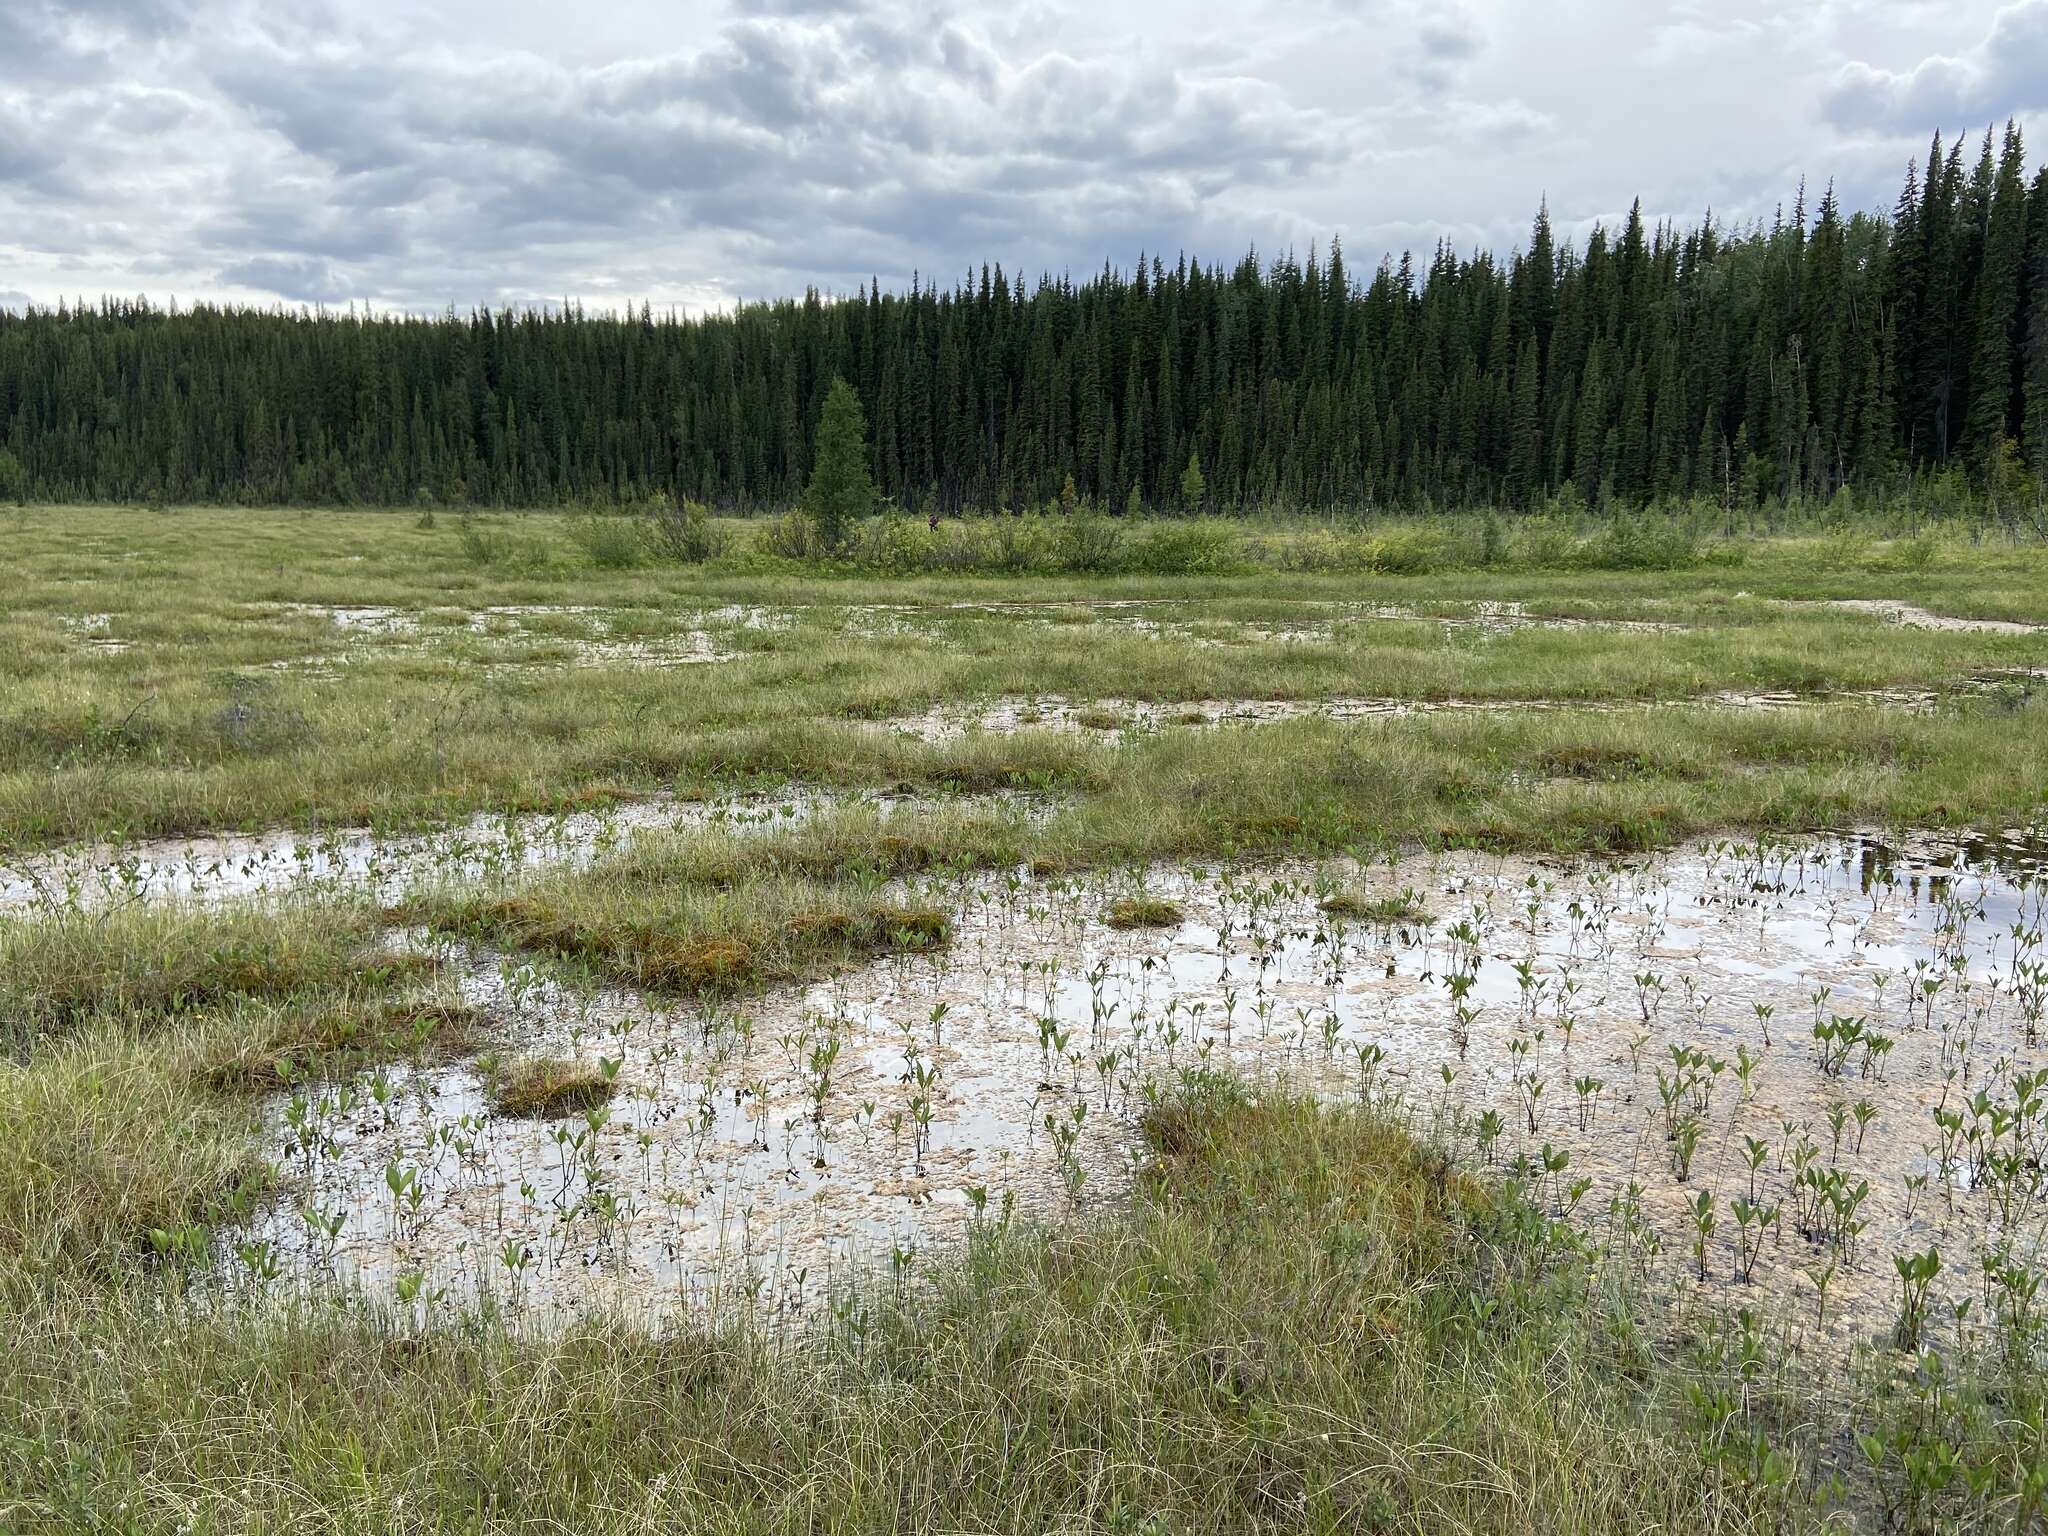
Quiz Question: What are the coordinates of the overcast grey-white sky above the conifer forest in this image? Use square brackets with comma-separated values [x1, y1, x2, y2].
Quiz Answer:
[0, 0, 2048, 309]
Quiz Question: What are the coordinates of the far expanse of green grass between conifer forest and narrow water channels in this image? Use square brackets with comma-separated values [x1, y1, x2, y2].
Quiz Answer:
[0, 508, 2048, 850]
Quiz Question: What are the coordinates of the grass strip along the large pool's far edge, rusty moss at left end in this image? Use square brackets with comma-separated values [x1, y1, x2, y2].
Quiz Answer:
[376, 702, 2048, 946]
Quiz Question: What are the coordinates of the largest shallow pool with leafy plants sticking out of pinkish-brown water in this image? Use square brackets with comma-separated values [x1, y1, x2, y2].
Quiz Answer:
[228, 838, 2048, 1331]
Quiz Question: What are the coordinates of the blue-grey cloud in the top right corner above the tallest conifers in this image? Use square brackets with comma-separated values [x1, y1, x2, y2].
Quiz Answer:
[1827, 0, 2048, 133]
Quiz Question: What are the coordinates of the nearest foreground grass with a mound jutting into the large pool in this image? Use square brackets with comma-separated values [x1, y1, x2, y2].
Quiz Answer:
[0, 1081, 1867, 1532]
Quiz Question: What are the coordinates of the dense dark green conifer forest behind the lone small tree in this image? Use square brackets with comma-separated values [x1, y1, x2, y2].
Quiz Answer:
[0, 125, 2048, 510]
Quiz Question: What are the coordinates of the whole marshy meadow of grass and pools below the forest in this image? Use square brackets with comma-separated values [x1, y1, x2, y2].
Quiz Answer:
[0, 506, 2048, 1536]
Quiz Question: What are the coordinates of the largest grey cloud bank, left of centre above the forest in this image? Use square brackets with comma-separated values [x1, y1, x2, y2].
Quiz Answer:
[159, 12, 1356, 299]
